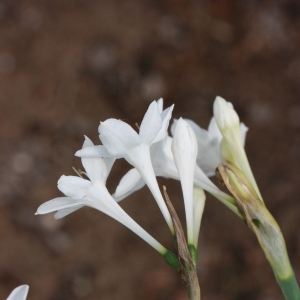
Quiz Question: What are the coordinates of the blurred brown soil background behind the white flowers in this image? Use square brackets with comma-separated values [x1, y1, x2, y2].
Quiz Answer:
[0, 0, 300, 300]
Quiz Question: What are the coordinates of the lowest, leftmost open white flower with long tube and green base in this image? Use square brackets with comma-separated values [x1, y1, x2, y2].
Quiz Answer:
[36, 137, 168, 255]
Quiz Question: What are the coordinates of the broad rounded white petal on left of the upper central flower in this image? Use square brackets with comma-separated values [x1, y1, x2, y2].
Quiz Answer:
[98, 119, 140, 156]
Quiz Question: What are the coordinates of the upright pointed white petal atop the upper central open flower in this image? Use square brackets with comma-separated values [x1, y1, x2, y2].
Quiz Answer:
[139, 101, 162, 145]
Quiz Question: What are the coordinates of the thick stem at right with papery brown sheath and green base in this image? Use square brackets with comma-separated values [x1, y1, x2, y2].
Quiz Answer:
[218, 163, 300, 300]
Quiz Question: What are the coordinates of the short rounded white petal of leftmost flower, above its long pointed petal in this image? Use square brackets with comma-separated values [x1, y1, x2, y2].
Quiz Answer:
[57, 175, 91, 199]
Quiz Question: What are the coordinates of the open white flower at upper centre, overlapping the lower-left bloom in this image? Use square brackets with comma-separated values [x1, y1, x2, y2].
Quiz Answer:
[76, 99, 174, 233]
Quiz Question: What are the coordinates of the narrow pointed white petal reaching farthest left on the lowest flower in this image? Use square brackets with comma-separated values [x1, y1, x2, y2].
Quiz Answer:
[36, 197, 83, 215]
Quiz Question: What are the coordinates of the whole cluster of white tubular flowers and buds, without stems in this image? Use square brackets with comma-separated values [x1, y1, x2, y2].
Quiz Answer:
[36, 97, 248, 268]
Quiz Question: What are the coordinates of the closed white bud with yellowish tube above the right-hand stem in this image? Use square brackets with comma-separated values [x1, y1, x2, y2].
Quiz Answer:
[213, 97, 263, 201]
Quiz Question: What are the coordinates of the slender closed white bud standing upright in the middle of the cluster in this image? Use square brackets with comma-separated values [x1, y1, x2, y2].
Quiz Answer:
[172, 118, 198, 245]
